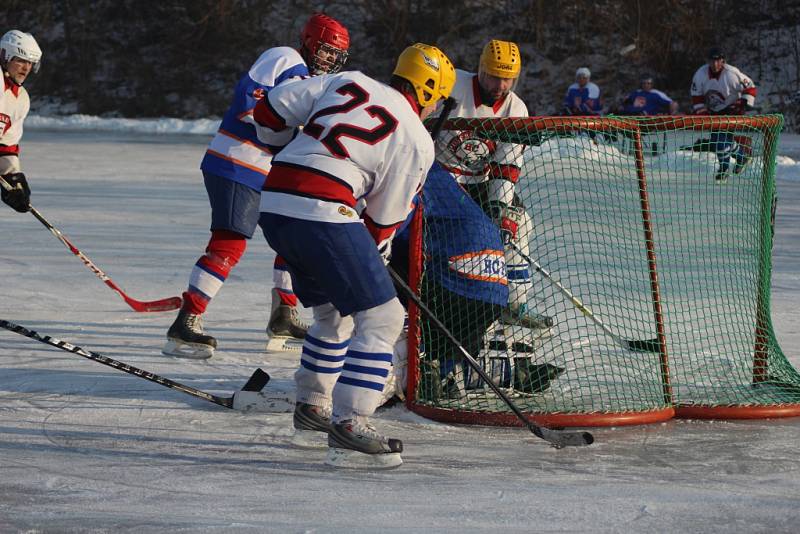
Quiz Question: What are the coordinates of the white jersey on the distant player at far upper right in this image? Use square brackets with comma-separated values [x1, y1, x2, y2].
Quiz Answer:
[691, 64, 756, 113]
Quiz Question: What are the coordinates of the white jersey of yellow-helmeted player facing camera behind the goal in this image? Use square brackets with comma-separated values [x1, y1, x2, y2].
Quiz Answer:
[436, 69, 528, 183]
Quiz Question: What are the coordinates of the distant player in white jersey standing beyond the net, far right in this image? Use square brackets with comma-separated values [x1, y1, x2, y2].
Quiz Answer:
[691, 47, 756, 183]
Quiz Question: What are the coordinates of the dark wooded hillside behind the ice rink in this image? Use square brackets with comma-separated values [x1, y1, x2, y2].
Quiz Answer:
[0, 0, 800, 130]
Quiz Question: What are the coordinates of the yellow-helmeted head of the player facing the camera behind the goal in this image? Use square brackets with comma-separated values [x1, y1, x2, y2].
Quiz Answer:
[478, 39, 522, 105]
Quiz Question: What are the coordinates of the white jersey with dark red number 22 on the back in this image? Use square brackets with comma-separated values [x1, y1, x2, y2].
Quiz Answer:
[254, 71, 434, 243]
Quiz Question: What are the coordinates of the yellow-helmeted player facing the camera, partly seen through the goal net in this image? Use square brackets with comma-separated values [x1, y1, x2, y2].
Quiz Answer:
[436, 39, 553, 338]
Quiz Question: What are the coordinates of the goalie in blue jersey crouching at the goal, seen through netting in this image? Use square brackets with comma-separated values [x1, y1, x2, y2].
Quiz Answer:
[384, 163, 564, 401]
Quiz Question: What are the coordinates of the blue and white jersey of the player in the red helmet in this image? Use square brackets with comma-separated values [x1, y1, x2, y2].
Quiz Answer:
[200, 46, 309, 191]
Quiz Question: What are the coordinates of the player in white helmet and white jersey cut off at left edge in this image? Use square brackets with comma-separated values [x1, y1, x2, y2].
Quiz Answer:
[0, 30, 42, 213]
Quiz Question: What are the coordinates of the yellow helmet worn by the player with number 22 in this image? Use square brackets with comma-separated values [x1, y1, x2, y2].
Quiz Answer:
[392, 43, 456, 107]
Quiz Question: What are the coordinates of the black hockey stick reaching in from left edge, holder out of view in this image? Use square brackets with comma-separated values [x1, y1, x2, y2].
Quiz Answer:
[0, 319, 270, 409]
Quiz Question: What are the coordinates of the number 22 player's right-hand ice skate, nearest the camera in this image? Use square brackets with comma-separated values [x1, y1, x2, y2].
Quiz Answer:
[325, 417, 403, 469]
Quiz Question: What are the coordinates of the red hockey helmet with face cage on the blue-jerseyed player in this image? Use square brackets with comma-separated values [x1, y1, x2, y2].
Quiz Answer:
[300, 13, 350, 75]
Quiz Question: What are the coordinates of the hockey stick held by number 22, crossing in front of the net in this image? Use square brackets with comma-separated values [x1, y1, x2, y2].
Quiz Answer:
[387, 266, 594, 449]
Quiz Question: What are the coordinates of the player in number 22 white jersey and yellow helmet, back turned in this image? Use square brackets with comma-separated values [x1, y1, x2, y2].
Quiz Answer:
[255, 44, 455, 467]
